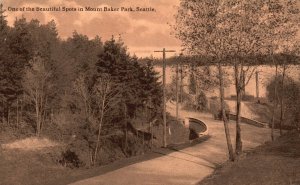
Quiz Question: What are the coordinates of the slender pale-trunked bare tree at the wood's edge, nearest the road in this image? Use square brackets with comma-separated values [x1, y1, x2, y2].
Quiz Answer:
[74, 75, 120, 165]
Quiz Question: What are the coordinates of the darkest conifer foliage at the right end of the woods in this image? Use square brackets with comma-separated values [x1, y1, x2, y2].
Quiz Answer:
[96, 38, 161, 117]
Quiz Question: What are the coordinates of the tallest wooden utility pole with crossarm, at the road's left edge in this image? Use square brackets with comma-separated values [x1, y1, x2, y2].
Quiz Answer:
[154, 48, 175, 147]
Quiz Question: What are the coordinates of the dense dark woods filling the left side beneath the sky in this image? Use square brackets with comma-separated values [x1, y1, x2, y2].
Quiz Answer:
[0, 10, 162, 167]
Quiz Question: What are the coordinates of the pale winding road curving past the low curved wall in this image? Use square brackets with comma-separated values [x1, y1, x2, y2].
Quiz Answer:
[72, 103, 270, 185]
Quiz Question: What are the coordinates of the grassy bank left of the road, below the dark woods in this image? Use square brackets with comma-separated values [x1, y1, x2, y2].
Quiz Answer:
[0, 118, 188, 185]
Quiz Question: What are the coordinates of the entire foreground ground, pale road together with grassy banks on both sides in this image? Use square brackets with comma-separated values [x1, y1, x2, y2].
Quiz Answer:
[0, 104, 300, 185]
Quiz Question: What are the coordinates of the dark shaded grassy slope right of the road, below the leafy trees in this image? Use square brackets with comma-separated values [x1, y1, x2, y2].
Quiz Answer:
[199, 133, 300, 185]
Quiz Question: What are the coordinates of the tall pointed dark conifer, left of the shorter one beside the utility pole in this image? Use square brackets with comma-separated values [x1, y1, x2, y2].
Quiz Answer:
[94, 38, 142, 117]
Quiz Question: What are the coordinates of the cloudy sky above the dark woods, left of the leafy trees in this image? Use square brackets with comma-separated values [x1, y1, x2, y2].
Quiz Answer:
[0, 0, 180, 57]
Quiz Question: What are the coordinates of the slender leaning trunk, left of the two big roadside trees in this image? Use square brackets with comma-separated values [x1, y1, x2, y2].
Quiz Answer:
[218, 62, 235, 161]
